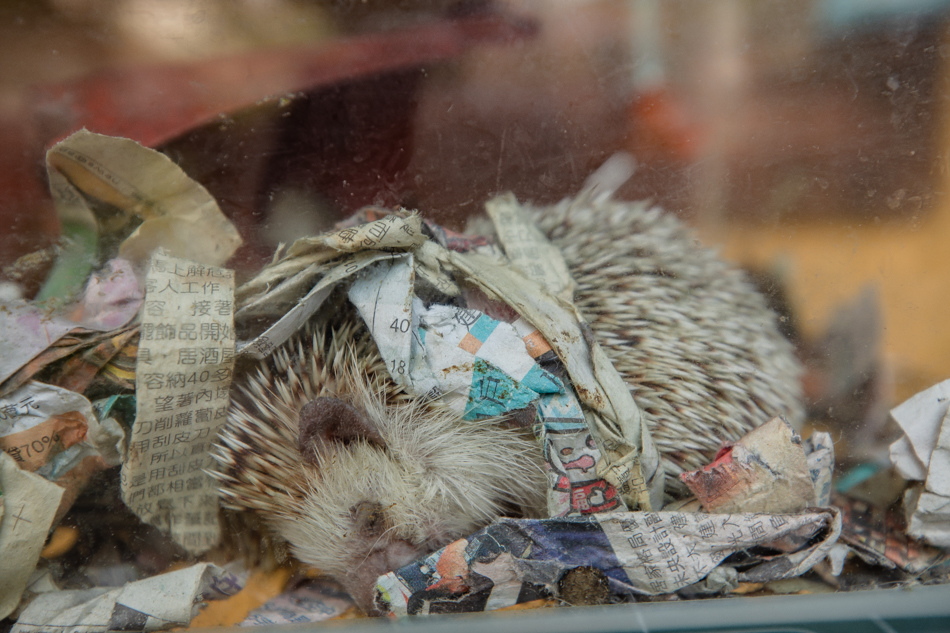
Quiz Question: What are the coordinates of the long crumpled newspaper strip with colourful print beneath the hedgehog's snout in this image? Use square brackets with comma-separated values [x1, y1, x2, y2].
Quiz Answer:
[376, 509, 841, 616]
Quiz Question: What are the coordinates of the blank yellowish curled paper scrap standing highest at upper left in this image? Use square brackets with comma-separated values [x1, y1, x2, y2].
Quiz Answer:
[38, 130, 241, 300]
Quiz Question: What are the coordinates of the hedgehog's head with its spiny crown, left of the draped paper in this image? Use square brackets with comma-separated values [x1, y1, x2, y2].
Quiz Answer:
[210, 315, 545, 613]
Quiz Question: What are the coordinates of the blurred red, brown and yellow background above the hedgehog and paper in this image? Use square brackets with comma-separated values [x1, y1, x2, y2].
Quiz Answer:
[0, 0, 950, 454]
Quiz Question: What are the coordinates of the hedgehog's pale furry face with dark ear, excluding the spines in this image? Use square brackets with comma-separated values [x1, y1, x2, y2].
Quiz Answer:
[274, 393, 544, 611]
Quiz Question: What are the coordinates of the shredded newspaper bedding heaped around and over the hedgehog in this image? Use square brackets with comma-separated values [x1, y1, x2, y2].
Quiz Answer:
[0, 131, 950, 631]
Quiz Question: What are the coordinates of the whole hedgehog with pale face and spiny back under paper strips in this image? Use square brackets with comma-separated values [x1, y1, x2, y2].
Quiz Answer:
[213, 196, 804, 613]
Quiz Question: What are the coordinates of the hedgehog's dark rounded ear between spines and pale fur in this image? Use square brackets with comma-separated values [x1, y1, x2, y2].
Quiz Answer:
[297, 397, 384, 463]
